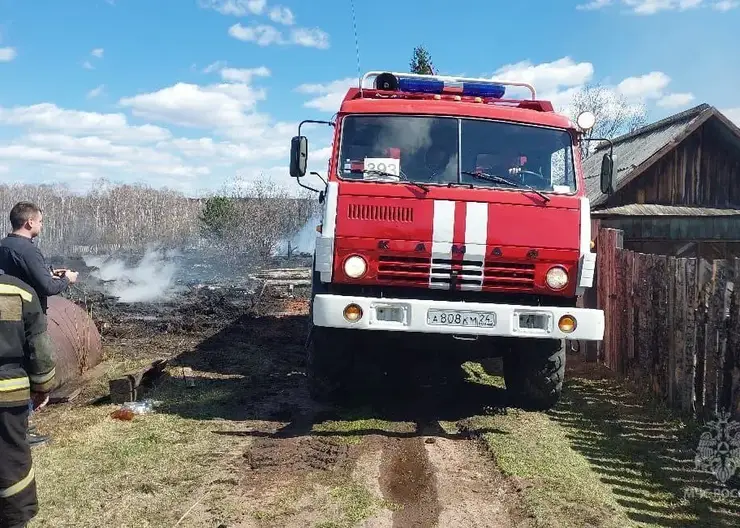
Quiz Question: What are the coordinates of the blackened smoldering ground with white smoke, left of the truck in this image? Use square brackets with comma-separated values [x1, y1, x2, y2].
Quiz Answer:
[52, 251, 310, 339]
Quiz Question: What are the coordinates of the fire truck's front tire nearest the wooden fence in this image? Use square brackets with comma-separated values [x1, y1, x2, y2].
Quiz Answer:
[504, 339, 565, 411]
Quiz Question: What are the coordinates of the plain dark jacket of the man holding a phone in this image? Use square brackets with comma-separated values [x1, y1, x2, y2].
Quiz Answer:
[0, 233, 69, 313]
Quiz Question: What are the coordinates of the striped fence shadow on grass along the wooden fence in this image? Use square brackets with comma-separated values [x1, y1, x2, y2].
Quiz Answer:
[548, 362, 740, 527]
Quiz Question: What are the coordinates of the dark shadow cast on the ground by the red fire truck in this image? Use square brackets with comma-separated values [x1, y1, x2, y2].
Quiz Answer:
[154, 315, 506, 438]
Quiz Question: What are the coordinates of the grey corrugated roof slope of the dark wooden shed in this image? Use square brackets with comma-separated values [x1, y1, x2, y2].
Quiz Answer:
[583, 104, 713, 207]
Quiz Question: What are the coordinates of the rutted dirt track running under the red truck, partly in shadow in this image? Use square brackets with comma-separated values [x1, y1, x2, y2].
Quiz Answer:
[168, 301, 528, 528]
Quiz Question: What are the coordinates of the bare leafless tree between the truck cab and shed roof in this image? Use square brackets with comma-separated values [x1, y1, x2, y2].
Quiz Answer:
[568, 84, 647, 159]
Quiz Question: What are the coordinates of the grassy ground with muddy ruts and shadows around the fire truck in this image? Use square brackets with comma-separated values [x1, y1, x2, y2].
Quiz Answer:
[31, 293, 740, 528]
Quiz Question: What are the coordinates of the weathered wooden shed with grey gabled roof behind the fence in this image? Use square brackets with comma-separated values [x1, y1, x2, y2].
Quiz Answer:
[583, 104, 740, 259]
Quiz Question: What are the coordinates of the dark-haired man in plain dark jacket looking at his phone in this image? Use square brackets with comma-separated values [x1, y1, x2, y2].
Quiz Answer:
[0, 202, 77, 447]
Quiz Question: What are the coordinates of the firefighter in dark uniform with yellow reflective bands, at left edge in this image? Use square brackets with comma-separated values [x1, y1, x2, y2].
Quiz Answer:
[0, 270, 55, 528]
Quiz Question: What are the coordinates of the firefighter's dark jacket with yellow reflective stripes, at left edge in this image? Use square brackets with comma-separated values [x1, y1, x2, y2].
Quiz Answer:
[0, 270, 56, 407]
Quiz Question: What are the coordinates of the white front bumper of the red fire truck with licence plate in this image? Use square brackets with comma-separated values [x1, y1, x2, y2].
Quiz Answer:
[312, 294, 604, 341]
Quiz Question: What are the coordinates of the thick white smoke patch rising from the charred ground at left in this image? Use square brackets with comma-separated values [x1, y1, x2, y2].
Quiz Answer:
[85, 247, 179, 303]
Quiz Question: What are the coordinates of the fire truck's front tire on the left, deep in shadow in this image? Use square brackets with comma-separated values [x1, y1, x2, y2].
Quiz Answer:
[306, 326, 354, 403]
